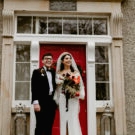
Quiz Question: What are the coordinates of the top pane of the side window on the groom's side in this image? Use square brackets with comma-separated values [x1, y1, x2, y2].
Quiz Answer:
[16, 45, 30, 62]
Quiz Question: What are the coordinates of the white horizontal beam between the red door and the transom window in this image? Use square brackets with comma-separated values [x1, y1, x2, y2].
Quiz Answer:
[14, 34, 112, 44]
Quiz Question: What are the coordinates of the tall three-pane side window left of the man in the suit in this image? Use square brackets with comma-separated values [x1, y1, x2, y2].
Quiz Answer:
[13, 45, 30, 106]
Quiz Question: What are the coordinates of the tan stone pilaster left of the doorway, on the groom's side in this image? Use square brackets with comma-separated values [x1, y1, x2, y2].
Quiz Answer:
[0, 10, 14, 135]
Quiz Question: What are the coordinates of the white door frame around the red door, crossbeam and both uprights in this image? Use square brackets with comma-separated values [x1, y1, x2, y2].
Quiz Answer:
[28, 35, 112, 135]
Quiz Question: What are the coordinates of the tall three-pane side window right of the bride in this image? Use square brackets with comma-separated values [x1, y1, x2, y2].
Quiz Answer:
[95, 46, 112, 106]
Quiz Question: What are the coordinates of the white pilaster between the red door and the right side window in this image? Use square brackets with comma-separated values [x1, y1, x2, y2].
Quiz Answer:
[87, 42, 97, 135]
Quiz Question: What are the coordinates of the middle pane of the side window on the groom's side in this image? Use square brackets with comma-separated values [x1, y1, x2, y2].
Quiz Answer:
[16, 63, 30, 81]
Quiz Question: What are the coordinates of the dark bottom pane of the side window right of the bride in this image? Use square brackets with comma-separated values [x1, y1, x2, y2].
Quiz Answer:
[96, 83, 110, 100]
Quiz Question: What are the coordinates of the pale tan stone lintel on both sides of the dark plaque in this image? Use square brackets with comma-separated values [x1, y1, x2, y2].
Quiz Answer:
[4, 0, 121, 13]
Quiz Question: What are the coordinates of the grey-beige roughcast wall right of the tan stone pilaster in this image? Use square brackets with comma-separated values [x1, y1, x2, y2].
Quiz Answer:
[122, 0, 135, 135]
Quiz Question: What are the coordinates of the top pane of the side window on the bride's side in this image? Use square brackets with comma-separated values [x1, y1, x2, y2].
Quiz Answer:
[95, 46, 108, 63]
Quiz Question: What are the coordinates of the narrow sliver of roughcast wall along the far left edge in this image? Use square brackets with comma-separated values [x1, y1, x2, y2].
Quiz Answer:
[0, 0, 3, 93]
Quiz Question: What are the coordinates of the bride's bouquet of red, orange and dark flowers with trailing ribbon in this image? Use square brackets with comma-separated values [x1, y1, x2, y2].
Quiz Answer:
[62, 73, 80, 111]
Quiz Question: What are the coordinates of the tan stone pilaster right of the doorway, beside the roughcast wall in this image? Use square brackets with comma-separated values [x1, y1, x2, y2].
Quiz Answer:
[112, 12, 127, 135]
